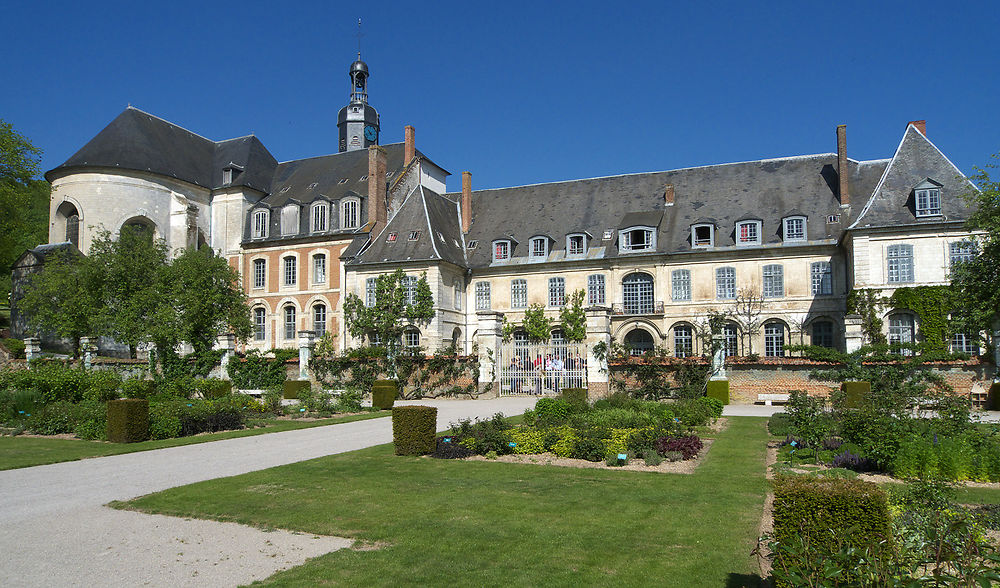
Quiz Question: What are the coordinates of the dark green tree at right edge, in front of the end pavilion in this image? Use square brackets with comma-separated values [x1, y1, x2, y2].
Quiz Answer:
[951, 154, 1000, 346]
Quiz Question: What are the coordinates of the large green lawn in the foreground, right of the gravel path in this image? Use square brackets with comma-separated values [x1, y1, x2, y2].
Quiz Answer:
[124, 417, 768, 587]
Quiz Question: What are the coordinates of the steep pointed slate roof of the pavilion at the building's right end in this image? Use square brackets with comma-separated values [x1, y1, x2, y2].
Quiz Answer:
[850, 125, 976, 229]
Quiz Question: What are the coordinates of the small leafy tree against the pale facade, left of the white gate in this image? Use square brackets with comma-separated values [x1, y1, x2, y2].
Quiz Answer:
[344, 269, 434, 347]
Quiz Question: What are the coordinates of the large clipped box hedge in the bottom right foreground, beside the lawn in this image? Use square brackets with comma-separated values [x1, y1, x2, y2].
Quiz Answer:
[774, 476, 892, 584]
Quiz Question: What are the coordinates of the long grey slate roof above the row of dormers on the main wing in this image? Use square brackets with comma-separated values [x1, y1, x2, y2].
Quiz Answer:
[456, 153, 888, 268]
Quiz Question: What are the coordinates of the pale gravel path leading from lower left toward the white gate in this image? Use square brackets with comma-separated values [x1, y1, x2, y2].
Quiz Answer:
[0, 398, 535, 587]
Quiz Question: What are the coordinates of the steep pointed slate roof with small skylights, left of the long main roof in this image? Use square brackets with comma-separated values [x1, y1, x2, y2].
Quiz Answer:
[351, 186, 465, 266]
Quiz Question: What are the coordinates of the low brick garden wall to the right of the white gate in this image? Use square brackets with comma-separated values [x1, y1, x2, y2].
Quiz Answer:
[611, 357, 994, 404]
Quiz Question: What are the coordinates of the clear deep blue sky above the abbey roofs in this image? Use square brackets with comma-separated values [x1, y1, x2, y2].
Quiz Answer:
[0, 0, 1000, 190]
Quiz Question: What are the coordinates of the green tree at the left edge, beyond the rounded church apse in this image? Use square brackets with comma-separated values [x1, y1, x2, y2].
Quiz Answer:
[0, 119, 50, 292]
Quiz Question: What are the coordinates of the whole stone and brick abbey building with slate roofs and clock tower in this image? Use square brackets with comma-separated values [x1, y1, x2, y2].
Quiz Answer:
[29, 59, 976, 396]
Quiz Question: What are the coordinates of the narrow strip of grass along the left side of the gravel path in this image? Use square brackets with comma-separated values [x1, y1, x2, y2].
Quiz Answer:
[0, 411, 390, 470]
